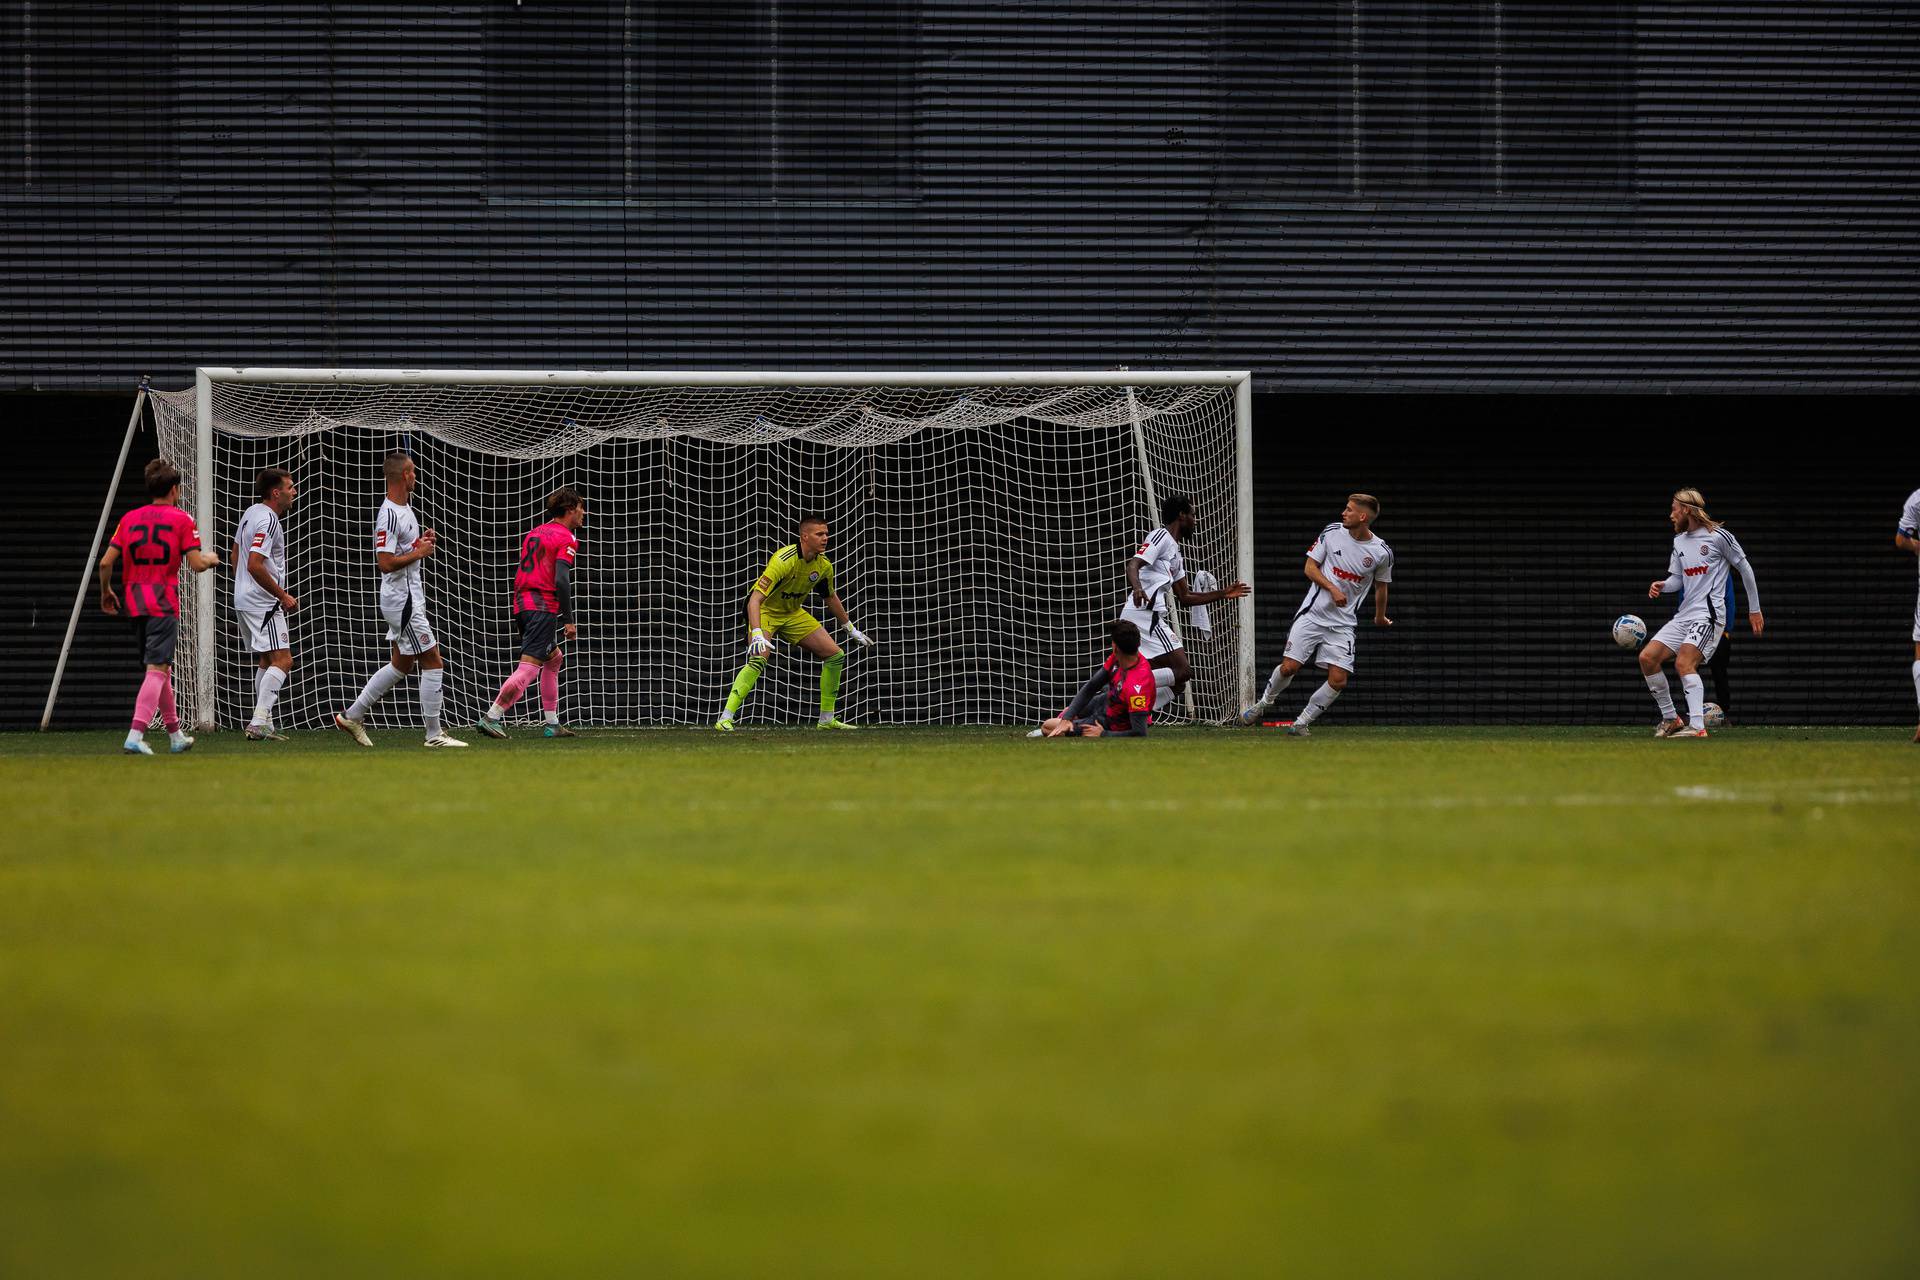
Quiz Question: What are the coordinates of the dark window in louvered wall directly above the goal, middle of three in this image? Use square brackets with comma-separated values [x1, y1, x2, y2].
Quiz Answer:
[488, 0, 916, 200]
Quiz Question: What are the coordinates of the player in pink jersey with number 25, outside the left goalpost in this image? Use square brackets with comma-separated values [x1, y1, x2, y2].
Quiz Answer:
[100, 459, 221, 756]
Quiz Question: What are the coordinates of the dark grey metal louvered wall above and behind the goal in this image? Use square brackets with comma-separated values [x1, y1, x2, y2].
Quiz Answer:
[0, 0, 1920, 391]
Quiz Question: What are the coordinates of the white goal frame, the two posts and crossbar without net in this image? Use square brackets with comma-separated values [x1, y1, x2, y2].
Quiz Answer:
[194, 365, 1256, 727]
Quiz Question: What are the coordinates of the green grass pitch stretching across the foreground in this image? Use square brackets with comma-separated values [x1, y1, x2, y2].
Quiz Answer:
[0, 720, 1920, 1278]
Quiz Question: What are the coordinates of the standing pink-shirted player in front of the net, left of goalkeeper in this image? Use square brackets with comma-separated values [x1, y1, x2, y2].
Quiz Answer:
[474, 486, 588, 737]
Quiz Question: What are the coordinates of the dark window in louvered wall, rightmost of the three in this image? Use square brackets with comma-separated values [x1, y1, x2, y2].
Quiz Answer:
[1219, 0, 1634, 200]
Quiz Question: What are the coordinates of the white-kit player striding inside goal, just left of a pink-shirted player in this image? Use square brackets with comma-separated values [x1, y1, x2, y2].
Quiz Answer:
[334, 449, 467, 747]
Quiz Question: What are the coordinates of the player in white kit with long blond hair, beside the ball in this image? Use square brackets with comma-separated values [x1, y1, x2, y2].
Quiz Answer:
[1640, 489, 1766, 737]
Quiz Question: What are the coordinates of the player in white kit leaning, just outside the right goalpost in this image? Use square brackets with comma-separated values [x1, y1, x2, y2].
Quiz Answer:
[1240, 493, 1394, 737]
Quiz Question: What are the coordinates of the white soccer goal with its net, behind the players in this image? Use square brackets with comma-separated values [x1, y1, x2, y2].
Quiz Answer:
[154, 368, 1254, 727]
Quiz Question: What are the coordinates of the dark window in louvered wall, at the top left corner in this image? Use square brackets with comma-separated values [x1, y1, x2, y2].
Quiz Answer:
[0, 0, 179, 196]
